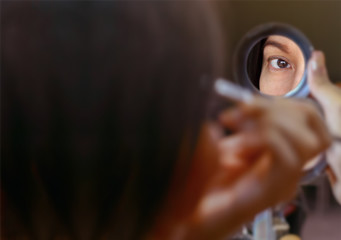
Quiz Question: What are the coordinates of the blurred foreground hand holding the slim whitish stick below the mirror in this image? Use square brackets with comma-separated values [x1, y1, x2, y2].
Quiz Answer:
[183, 96, 330, 239]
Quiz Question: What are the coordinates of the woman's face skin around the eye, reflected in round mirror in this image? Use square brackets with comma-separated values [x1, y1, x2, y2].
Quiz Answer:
[259, 35, 305, 96]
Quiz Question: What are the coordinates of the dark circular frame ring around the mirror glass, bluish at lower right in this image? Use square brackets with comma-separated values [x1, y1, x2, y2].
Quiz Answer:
[233, 22, 314, 98]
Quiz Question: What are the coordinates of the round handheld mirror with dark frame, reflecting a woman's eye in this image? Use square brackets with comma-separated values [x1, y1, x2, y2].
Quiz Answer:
[234, 23, 313, 97]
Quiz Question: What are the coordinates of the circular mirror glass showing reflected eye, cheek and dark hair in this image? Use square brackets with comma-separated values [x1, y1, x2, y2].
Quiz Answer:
[247, 35, 305, 96]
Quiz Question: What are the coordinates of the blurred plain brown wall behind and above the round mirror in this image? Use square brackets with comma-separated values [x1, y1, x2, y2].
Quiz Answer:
[216, 0, 341, 82]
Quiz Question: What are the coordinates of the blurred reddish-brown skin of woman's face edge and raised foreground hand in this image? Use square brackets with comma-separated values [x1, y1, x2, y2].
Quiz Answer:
[147, 91, 330, 240]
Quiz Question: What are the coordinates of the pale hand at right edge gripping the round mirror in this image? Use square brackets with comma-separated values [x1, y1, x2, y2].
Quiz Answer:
[308, 51, 341, 204]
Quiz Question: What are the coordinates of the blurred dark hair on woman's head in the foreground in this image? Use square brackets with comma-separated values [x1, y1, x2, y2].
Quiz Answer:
[1, 1, 223, 239]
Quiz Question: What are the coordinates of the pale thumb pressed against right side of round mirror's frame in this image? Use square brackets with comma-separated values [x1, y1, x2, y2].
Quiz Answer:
[308, 51, 332, 105]
